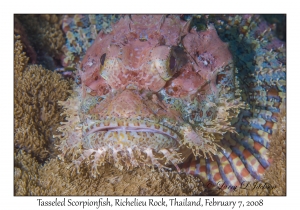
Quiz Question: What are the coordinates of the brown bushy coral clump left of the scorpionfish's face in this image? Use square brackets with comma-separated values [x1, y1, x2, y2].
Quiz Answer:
[14, 37, 70, 160]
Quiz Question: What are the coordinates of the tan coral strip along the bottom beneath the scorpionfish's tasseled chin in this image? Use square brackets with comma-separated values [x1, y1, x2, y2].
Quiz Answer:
[14, 151, 206, 196]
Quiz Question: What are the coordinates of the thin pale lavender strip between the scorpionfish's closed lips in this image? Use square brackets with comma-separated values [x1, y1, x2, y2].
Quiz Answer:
[84, 122, 179, 141]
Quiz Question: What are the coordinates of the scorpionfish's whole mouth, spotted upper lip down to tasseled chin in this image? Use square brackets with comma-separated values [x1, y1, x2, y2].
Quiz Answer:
[82, 119, 183, 171]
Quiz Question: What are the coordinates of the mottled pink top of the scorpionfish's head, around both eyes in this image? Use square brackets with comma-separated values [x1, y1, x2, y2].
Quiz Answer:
[80, 15, 232, 97]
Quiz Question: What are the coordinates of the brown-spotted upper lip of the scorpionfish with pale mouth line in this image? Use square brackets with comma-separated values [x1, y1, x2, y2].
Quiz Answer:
[83, 119, 179, 141]
